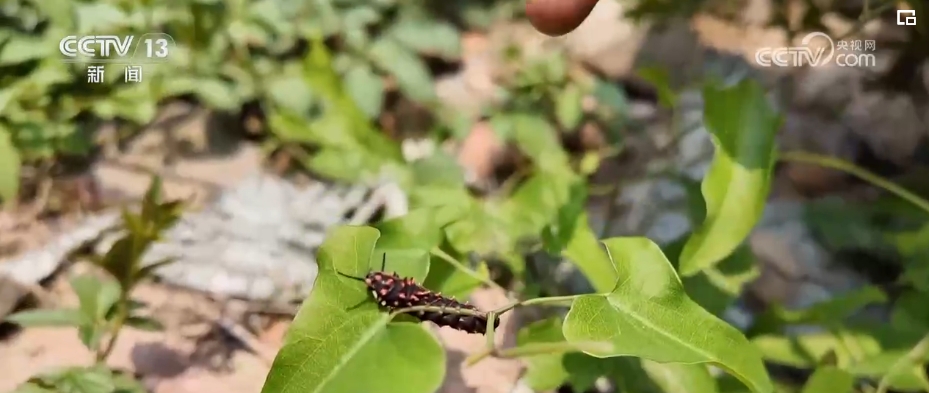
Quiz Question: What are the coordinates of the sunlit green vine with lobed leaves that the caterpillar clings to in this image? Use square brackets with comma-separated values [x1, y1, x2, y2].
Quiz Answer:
[256, 76, 779, 392]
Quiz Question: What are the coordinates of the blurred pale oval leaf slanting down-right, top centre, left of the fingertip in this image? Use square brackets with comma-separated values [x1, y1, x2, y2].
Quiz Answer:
[369, 37, 436, 103]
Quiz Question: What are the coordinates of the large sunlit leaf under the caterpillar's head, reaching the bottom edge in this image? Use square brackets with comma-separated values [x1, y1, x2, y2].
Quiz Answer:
[262, 226, 446, 393]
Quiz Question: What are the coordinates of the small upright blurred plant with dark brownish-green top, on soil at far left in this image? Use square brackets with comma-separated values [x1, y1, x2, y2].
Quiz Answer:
[6, 178, 182, 393]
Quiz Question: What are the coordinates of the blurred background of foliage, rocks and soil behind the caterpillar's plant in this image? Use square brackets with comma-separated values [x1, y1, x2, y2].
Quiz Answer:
[0, 0, 929, 393]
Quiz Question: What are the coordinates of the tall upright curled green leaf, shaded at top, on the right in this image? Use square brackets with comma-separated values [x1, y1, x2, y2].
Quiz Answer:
[680, 79, 782, 276]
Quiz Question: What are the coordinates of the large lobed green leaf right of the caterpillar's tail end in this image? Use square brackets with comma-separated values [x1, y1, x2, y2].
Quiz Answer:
[564, 238, 774, 393]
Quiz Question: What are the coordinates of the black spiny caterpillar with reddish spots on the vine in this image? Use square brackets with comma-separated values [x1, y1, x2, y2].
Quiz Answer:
[337, 253, 492, 334]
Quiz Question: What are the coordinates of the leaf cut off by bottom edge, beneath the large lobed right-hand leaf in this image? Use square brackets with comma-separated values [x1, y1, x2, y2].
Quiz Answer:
[642, 359, 719, 393]
